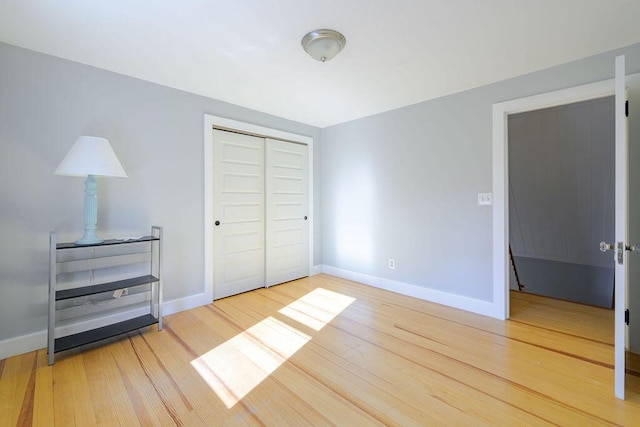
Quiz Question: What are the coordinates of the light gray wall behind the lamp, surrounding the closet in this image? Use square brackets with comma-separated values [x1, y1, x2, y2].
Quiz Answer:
[0, 44, 322, 341]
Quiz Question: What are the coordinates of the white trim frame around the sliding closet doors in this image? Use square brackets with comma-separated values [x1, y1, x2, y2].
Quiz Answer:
[204, 114, 314, 301]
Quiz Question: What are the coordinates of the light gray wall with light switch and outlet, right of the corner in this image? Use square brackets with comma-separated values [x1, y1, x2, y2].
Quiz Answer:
[321, 44, 640, 304]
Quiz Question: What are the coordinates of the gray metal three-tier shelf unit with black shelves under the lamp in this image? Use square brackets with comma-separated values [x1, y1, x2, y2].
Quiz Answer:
[47, 226, 162, 365]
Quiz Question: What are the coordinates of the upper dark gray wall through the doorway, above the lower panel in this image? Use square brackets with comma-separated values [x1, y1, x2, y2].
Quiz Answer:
[509, 97, 615, 267]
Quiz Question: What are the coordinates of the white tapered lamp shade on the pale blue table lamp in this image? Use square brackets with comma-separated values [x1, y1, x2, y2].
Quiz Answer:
[55, 136, 127, 178]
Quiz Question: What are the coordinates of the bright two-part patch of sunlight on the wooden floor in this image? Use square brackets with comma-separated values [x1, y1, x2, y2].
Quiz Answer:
[191, 288, 355, 409]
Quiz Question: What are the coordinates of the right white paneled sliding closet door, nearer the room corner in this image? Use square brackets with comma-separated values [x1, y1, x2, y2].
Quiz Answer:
[266, 139, 309, 286]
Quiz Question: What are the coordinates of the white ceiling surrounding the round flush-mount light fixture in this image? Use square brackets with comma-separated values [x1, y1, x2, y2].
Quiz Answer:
[0, 0, 640, 127]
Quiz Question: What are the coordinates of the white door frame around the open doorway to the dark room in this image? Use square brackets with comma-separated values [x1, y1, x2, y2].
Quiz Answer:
[493, 79, 614, 319]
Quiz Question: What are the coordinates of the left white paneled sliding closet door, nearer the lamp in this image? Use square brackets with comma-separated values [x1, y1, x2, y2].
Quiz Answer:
[209, 130, 265, 299]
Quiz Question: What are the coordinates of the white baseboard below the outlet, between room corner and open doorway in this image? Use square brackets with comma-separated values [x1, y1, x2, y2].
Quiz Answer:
[322, 265, 502, 319]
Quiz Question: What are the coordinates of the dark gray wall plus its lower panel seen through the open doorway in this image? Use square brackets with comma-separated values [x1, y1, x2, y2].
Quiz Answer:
[508, 96, 615, 308]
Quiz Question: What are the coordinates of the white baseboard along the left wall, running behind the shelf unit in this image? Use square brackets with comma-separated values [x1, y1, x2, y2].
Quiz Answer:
[0, 293, 211, 360]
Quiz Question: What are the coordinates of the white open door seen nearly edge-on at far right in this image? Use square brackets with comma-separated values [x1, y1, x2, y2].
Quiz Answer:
[614, 56, 629, 399]
